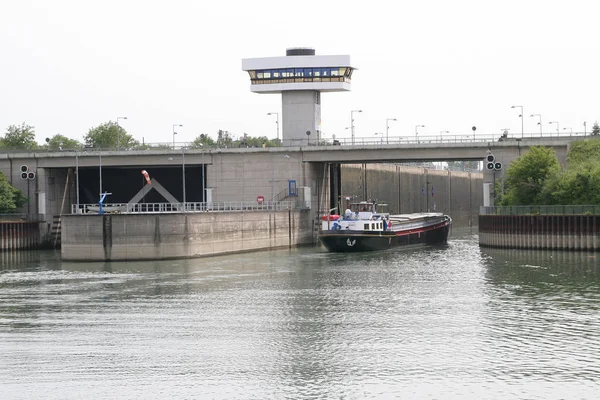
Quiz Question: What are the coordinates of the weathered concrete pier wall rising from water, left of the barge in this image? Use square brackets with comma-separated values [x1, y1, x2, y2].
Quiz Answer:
[61, 210, 313, 261]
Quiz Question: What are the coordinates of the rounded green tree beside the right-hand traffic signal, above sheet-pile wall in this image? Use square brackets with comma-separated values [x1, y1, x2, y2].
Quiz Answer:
[495, 146, 560, 206]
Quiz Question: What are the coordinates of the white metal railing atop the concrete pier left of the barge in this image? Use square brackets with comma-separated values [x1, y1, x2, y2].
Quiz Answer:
[71, 201, 294, 214]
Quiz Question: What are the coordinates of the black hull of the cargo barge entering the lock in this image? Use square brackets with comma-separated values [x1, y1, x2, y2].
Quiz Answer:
[319, 222, 450, 253]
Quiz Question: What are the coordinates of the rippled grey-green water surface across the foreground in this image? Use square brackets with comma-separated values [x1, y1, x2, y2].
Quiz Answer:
[0, 230, 600, 399]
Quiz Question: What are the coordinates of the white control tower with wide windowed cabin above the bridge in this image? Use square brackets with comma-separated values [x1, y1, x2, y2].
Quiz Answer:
[242, 47, 355, 146]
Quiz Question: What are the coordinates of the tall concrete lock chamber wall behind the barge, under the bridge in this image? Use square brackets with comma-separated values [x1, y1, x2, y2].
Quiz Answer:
[342, 164, 483, 226]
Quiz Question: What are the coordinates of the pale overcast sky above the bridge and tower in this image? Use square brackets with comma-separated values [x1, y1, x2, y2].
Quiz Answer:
[0, 0, 600, 143]
